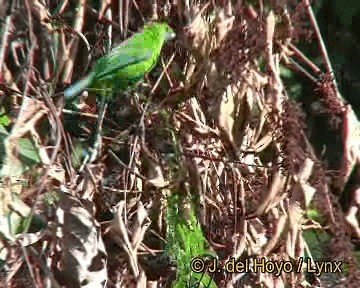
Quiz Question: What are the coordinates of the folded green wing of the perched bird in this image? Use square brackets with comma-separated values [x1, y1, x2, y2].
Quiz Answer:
[95, 45, 152, 80]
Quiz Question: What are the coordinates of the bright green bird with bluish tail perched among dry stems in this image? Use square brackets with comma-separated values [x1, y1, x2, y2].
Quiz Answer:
[64, 23, 175, 97]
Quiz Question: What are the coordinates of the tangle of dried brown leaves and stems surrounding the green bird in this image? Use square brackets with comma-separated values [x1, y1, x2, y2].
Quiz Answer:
[0, 0, 360, 287]
